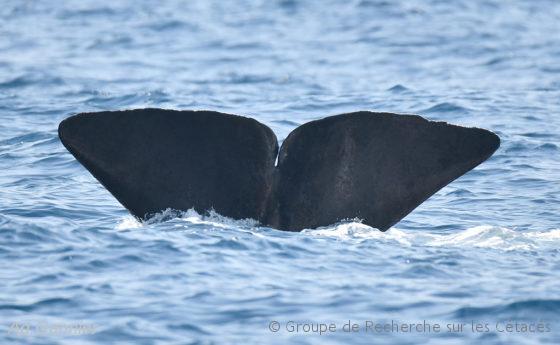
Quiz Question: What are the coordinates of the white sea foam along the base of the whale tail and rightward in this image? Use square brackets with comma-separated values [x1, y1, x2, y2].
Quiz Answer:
[116, 209, 560, 250]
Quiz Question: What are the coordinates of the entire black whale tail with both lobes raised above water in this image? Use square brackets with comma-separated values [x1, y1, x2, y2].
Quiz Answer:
[58, 109, 500, 231]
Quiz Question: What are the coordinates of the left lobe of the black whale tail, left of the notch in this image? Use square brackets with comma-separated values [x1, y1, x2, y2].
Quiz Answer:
[58, 109, 278, 219]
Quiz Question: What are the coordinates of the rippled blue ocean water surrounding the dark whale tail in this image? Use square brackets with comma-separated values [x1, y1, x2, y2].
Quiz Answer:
[0, 0, 560, 344]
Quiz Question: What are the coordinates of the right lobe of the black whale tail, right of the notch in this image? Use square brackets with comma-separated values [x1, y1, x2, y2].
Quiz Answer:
[269, 112, 500, 230]
